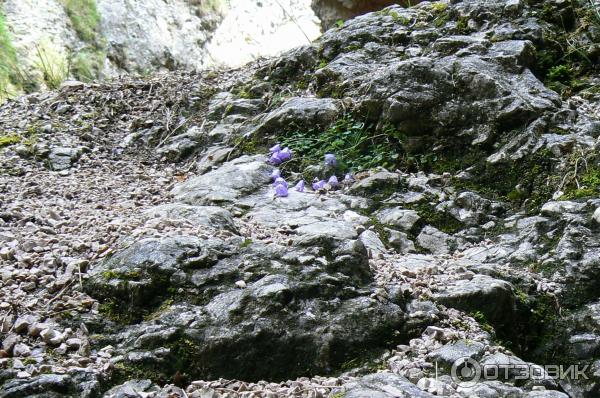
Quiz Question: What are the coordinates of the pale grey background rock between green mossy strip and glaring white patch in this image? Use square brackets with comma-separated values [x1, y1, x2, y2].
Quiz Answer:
[98, 0, 226, 73]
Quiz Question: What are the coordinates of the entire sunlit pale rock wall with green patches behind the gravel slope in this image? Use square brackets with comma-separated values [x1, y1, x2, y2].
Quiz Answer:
[0, 0, 321, 98]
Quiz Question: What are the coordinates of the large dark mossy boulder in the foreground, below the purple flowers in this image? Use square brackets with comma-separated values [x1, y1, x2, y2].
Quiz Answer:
[85, 236, 405, 380]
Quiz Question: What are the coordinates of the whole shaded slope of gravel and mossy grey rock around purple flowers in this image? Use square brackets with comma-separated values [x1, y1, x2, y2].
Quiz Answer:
[0, 0, 600, 398]
